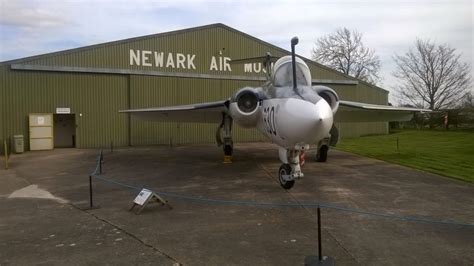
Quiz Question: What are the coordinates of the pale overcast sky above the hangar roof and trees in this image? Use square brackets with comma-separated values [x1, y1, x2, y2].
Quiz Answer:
[0, 0, 474, 100]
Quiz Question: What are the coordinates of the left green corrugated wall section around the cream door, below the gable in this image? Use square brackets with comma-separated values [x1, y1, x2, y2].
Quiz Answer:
[2, 65, 128, 149]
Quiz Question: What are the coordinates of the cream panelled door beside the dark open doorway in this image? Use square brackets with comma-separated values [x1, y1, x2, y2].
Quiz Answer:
[29, 114, 54, 151]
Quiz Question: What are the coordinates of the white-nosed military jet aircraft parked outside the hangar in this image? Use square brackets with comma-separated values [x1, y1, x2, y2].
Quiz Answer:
[119, 37, 430, 189]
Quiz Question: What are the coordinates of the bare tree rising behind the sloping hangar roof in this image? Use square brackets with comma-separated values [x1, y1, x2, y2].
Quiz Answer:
[312, 28, 380, 84]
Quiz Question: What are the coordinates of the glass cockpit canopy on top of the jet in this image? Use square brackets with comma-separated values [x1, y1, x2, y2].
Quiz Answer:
[272, 55, 311, 87]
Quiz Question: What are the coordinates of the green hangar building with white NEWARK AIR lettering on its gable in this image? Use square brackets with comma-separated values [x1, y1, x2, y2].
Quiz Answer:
[0, 24, 388, 150]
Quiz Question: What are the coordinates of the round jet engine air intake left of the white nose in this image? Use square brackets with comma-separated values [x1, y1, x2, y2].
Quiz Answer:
[229, 87, 260, 127]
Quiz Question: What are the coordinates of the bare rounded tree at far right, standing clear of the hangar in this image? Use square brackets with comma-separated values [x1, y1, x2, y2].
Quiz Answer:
[393, 39, 471, 110]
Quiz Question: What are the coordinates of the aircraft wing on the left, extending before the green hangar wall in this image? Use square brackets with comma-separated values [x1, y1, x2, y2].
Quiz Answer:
[119, 100, 229, 123]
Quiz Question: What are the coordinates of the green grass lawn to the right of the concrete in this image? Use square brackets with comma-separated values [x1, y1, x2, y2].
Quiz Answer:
[336, 129, 474, 183]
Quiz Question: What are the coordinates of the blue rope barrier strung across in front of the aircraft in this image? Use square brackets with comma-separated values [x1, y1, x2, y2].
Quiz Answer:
[91, 156, 474, 228]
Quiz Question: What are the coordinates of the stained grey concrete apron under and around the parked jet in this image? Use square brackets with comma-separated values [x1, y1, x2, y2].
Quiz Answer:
[0, 143, 474, 265]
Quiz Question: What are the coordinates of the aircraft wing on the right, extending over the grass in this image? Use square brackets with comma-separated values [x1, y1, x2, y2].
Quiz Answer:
[334, 101, 431, 122]
